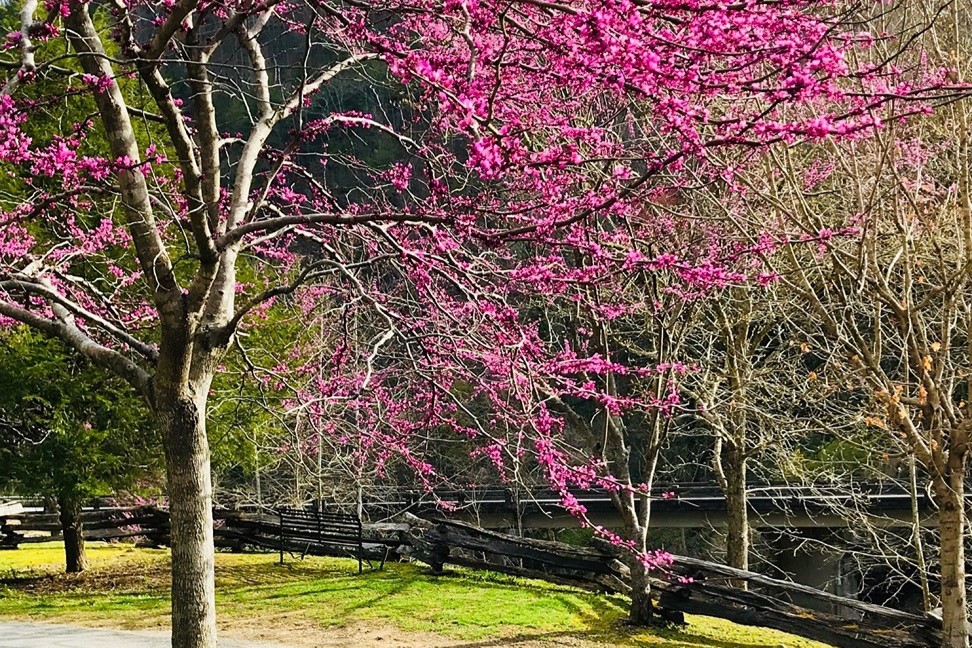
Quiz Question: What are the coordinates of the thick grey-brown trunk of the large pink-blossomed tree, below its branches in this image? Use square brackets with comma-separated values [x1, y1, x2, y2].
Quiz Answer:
[156, 394, 216, 648]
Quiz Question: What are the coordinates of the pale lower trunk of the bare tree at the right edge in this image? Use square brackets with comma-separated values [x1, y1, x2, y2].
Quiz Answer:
[935, 470, 969, 648]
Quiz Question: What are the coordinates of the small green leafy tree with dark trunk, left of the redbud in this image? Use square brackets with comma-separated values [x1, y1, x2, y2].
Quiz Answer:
[0, 328, 159, 572]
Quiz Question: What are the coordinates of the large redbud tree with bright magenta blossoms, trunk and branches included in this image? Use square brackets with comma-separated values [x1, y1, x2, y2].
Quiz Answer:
[0, 0, 944, 648]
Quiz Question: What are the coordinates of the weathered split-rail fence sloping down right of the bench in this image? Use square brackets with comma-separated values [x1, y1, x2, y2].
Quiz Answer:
[408, 516, 941, 648]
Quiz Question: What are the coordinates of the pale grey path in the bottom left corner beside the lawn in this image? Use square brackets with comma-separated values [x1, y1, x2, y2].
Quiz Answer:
[0, 621, 285, 648]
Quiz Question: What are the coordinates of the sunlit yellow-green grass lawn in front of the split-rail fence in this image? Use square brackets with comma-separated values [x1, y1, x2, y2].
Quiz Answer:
[0, 543, 825, 648]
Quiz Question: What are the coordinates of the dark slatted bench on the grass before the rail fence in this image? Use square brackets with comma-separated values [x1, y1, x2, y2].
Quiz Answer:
[277, 508, 364, 574]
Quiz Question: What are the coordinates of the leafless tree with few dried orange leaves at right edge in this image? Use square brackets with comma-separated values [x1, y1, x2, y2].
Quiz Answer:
[744, 74, 972, 648]
